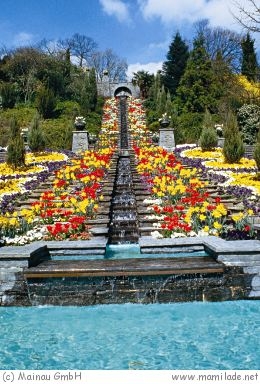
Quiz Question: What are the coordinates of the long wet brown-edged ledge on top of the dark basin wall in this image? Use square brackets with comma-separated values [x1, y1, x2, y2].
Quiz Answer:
[24, 257, 224, 279]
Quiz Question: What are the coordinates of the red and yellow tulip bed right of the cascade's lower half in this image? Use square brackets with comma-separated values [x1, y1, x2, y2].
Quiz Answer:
[135, 147, 254, 238]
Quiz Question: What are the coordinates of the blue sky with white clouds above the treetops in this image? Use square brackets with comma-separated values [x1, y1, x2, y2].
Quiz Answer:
[0, 0, 260, 78]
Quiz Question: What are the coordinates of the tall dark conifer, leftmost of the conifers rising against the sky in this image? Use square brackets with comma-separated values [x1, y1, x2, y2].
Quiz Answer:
[162, 32, 189, 96]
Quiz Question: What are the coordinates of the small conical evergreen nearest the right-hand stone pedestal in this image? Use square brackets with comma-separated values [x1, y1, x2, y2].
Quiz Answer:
[199, 110, 218, 151]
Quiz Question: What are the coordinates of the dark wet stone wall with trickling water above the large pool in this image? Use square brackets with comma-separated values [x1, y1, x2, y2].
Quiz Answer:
[24, 268, 251, 305]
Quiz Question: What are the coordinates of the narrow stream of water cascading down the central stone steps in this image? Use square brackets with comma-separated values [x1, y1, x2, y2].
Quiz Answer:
[109, 97, 139, 244]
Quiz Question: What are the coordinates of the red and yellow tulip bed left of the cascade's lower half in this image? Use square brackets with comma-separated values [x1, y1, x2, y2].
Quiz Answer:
[0, 149, 113, 245]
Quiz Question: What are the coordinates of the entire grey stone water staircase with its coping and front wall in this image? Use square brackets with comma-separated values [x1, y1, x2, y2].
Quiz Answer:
[0, 97, 260, 306]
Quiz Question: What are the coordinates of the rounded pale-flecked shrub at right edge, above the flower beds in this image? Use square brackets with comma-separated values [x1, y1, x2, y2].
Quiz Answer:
[237, 104, 260, 144]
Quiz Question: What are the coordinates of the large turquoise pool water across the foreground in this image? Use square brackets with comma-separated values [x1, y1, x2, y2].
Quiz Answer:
[0, 301, 260, 370]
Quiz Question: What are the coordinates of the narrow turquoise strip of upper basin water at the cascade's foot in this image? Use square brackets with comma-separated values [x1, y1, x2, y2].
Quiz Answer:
[51, 244, 208, 260]
